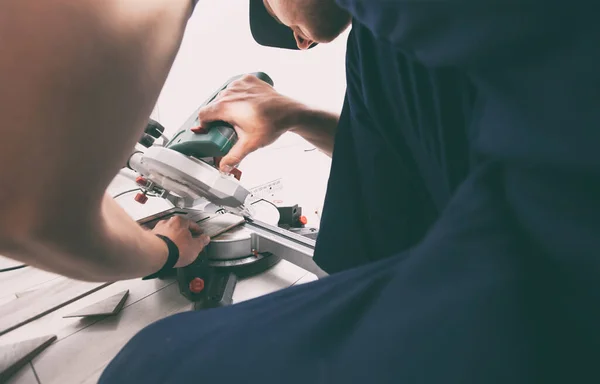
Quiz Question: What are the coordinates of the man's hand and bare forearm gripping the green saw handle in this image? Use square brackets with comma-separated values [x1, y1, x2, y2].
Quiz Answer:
[198, 75, 338, 172]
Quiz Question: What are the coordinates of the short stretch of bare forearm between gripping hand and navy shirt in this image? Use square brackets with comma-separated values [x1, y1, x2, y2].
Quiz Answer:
[290, 109, 339, 157]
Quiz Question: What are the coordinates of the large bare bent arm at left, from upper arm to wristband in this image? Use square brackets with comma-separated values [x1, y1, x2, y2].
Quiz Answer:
[0, 0, 191, 280]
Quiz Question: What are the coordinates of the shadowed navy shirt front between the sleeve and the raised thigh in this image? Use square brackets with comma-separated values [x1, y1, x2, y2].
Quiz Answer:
[315, 15, 474, 273]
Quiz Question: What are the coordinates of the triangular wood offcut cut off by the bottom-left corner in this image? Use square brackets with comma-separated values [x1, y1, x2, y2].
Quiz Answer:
[0, 335, 56, 383]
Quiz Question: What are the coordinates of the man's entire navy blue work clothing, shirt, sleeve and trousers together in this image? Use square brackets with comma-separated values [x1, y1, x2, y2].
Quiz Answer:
[100, 0, 600, 384]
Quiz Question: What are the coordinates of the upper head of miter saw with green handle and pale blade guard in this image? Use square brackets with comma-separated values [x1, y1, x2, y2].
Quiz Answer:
[128, 72, 273, 217]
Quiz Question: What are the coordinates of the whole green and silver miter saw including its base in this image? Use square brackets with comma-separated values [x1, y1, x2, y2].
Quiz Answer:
[127, 72, 326, 309]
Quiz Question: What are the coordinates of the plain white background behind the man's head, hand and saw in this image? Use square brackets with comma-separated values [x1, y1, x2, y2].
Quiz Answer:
[146, 0, 347, 225]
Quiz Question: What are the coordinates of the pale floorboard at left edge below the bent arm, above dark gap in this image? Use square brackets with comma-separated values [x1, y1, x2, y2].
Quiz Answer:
[0, 279, 110, 336]
